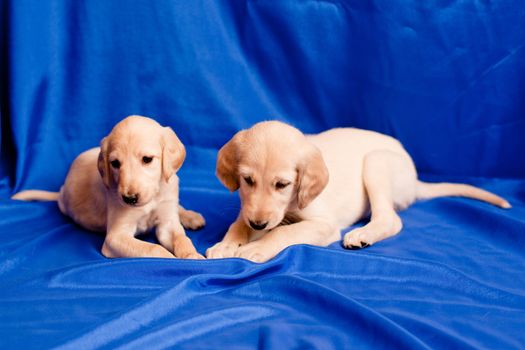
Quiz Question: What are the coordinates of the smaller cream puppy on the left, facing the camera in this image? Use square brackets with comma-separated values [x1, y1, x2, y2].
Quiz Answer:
[13, 116, 204, 259]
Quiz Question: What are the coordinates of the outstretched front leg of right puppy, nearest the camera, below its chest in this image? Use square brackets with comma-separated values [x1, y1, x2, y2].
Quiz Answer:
[235, 220, 341, 262]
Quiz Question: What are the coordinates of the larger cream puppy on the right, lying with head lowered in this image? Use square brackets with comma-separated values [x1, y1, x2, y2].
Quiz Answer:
[206, 121, 510, 262]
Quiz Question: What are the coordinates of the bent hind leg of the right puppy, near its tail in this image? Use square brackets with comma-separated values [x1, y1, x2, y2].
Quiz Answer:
[343, 151, 417, 249]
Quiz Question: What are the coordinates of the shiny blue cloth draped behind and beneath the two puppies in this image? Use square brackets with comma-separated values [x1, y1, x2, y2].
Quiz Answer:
[0, 0, 525, 349]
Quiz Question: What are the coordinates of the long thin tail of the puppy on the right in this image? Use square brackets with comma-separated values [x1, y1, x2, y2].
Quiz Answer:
[417, 181, 511, 209]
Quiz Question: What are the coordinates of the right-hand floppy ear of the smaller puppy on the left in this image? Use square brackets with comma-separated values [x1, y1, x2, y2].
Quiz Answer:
[161, 127, 186, 182]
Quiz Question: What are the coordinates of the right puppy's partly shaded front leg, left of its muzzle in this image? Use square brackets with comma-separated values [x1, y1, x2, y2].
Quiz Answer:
[206, 215, 251, 259]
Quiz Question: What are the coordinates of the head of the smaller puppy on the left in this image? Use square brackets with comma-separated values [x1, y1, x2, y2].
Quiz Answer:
[98, 116, 186, 206]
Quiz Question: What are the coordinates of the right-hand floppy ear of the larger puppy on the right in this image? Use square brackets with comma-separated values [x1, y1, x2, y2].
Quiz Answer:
[297, 145, 329, 209]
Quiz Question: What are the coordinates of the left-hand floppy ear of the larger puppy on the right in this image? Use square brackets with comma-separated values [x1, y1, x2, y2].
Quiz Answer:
[216, 131, 244, 192]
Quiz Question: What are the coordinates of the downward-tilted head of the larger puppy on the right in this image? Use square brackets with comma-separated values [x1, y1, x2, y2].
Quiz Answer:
[217, 121, 328, 230]
